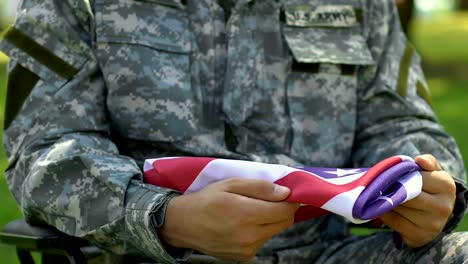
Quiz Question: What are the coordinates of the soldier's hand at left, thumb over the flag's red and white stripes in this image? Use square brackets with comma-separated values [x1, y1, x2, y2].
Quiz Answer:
[159, 178, 299, 261]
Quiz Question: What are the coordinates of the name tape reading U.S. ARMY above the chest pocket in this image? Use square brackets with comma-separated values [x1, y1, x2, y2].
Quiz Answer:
[284, 5, 359, 27]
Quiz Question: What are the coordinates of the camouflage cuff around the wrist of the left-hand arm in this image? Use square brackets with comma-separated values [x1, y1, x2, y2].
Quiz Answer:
[125, 183, 192, 263]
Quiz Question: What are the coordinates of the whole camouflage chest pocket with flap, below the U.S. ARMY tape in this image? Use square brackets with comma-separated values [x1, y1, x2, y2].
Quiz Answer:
[283, 15, 374, 166]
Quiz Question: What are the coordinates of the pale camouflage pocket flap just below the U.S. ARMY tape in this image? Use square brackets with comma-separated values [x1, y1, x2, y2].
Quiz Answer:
[283, 26, 374, 65]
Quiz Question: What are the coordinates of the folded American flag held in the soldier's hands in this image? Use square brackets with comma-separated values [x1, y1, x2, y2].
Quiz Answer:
[144, 156, 422, 223]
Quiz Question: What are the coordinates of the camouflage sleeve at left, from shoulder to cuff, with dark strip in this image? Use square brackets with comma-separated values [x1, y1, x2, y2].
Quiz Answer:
[0, 0, 186, 263]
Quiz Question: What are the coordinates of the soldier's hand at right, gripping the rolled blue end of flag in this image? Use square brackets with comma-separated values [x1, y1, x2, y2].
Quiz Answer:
[381, 154, 456, 247]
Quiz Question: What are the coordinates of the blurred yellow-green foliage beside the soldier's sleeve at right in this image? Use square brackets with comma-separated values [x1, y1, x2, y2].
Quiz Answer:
[410, 11, 468, 231]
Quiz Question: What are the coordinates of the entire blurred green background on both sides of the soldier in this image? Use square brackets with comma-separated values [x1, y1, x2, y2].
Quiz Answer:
[0, 0, 468, 264]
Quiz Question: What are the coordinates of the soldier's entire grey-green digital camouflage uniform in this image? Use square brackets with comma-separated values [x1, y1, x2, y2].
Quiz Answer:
[1, 0, 468, 263]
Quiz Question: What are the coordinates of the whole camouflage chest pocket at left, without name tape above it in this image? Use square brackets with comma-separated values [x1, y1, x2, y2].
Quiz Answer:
[95, 0, 200, 142]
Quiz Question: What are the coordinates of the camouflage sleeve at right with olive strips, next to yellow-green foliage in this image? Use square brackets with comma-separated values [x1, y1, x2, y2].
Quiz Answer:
[353, 1, 468, 232]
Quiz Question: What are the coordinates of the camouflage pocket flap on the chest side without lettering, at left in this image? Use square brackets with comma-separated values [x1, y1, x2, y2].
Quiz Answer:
[96, 1, 191, 53]
